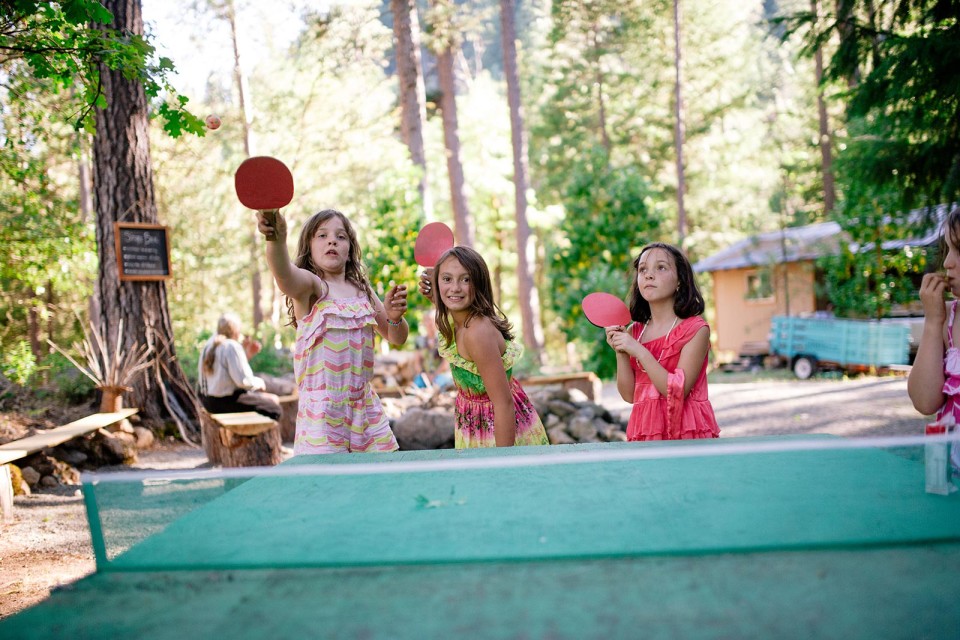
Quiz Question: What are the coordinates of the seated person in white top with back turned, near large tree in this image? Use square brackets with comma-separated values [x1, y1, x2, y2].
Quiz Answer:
[198, 313, 282, 420]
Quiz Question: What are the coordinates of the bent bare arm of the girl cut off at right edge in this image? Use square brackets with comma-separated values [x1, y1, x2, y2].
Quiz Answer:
[907, 273, 947, 415]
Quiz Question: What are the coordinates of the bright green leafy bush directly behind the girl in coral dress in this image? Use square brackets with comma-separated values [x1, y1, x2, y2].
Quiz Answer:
[549, 149, 661, 377]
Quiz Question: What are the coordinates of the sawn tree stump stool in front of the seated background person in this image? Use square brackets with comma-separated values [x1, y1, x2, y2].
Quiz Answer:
[203, 411, 283, 467]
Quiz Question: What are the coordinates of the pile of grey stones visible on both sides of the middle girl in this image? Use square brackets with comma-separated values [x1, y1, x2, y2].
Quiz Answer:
[382, 387, 627, 450]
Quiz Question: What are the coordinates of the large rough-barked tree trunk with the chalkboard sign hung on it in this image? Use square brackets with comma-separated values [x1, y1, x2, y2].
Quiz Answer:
[91, 0, 200, 440]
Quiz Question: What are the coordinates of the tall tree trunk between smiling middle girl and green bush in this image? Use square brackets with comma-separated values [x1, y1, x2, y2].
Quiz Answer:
[500, 0, 543, 363]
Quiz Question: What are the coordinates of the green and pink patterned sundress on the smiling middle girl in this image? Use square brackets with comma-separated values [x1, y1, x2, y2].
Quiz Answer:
[439, 336, 550, 449]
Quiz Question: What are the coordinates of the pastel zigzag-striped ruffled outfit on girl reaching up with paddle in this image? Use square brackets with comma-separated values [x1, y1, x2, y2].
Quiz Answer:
[293, 296, 399, 455]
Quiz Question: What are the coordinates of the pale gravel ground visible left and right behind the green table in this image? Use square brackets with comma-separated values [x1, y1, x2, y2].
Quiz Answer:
[0, 376, 925, 617]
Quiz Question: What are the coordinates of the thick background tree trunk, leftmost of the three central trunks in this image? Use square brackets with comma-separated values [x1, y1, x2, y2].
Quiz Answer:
[390, 0, 433, 220]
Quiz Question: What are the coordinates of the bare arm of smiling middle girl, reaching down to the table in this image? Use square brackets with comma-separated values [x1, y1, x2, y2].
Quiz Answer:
[457, 318, 517, 447]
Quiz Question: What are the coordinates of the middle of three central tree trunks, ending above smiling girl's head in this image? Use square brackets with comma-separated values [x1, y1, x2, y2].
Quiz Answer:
[437, 44, 474, 247]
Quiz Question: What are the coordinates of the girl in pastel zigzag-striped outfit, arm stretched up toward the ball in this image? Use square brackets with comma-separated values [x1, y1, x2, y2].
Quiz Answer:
[257, 209, 409, 455]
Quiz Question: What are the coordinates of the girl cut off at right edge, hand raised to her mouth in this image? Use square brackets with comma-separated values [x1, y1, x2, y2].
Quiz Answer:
[907, 207, 960, 482]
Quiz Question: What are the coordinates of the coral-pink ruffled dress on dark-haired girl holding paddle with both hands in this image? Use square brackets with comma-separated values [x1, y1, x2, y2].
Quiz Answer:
[627, 316, 720, 440]
